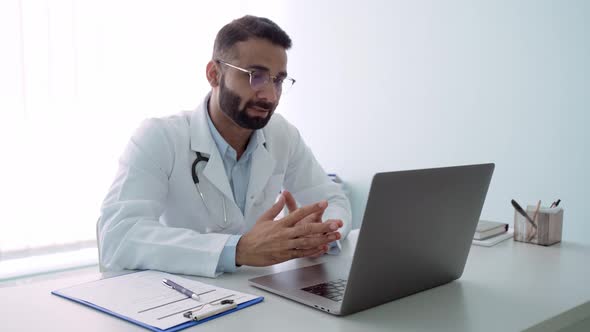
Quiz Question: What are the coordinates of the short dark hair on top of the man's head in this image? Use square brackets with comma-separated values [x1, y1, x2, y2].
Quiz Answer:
[213, 15, 291, 58]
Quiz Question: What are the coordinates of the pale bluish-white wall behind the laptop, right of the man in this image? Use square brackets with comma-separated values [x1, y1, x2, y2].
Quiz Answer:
[266, 0, 590, 242]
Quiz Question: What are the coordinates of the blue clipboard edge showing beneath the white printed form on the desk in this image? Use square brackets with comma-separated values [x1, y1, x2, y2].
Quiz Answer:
[51, 284, 264, 332]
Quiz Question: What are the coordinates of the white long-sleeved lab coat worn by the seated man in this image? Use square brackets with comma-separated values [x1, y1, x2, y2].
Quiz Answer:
[98, 98, 351, 277]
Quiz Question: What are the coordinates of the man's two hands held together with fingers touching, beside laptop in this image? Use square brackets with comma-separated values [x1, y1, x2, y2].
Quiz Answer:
[236, 194, 343, 266]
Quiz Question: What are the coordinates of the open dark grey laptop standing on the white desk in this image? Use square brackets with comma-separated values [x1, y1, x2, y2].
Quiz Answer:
[249, 164, 494, 315]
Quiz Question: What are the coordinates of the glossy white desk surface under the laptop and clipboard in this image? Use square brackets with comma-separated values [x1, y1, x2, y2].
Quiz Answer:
[0, 231, 590, 332]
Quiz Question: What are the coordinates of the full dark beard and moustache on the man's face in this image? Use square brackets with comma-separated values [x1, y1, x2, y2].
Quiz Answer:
[219, 77, 277, 130]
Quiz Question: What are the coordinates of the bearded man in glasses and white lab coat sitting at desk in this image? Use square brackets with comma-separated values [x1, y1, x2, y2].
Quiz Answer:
[98, 16, 351, 277]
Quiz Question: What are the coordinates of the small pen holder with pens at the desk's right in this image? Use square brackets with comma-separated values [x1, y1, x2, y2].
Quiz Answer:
[514, 205, 563, 246]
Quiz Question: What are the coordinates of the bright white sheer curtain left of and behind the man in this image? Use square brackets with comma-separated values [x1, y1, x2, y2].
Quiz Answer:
[0, 0, 253, 259]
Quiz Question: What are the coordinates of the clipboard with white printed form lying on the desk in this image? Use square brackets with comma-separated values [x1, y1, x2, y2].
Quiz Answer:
[52, 270, 263, 331]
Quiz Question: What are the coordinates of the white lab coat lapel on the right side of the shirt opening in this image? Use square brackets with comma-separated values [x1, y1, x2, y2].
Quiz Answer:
[245, 144, 276, 215]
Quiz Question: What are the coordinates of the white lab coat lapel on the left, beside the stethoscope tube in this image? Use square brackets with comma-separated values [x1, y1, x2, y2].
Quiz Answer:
[190, 101, 234, 202]
